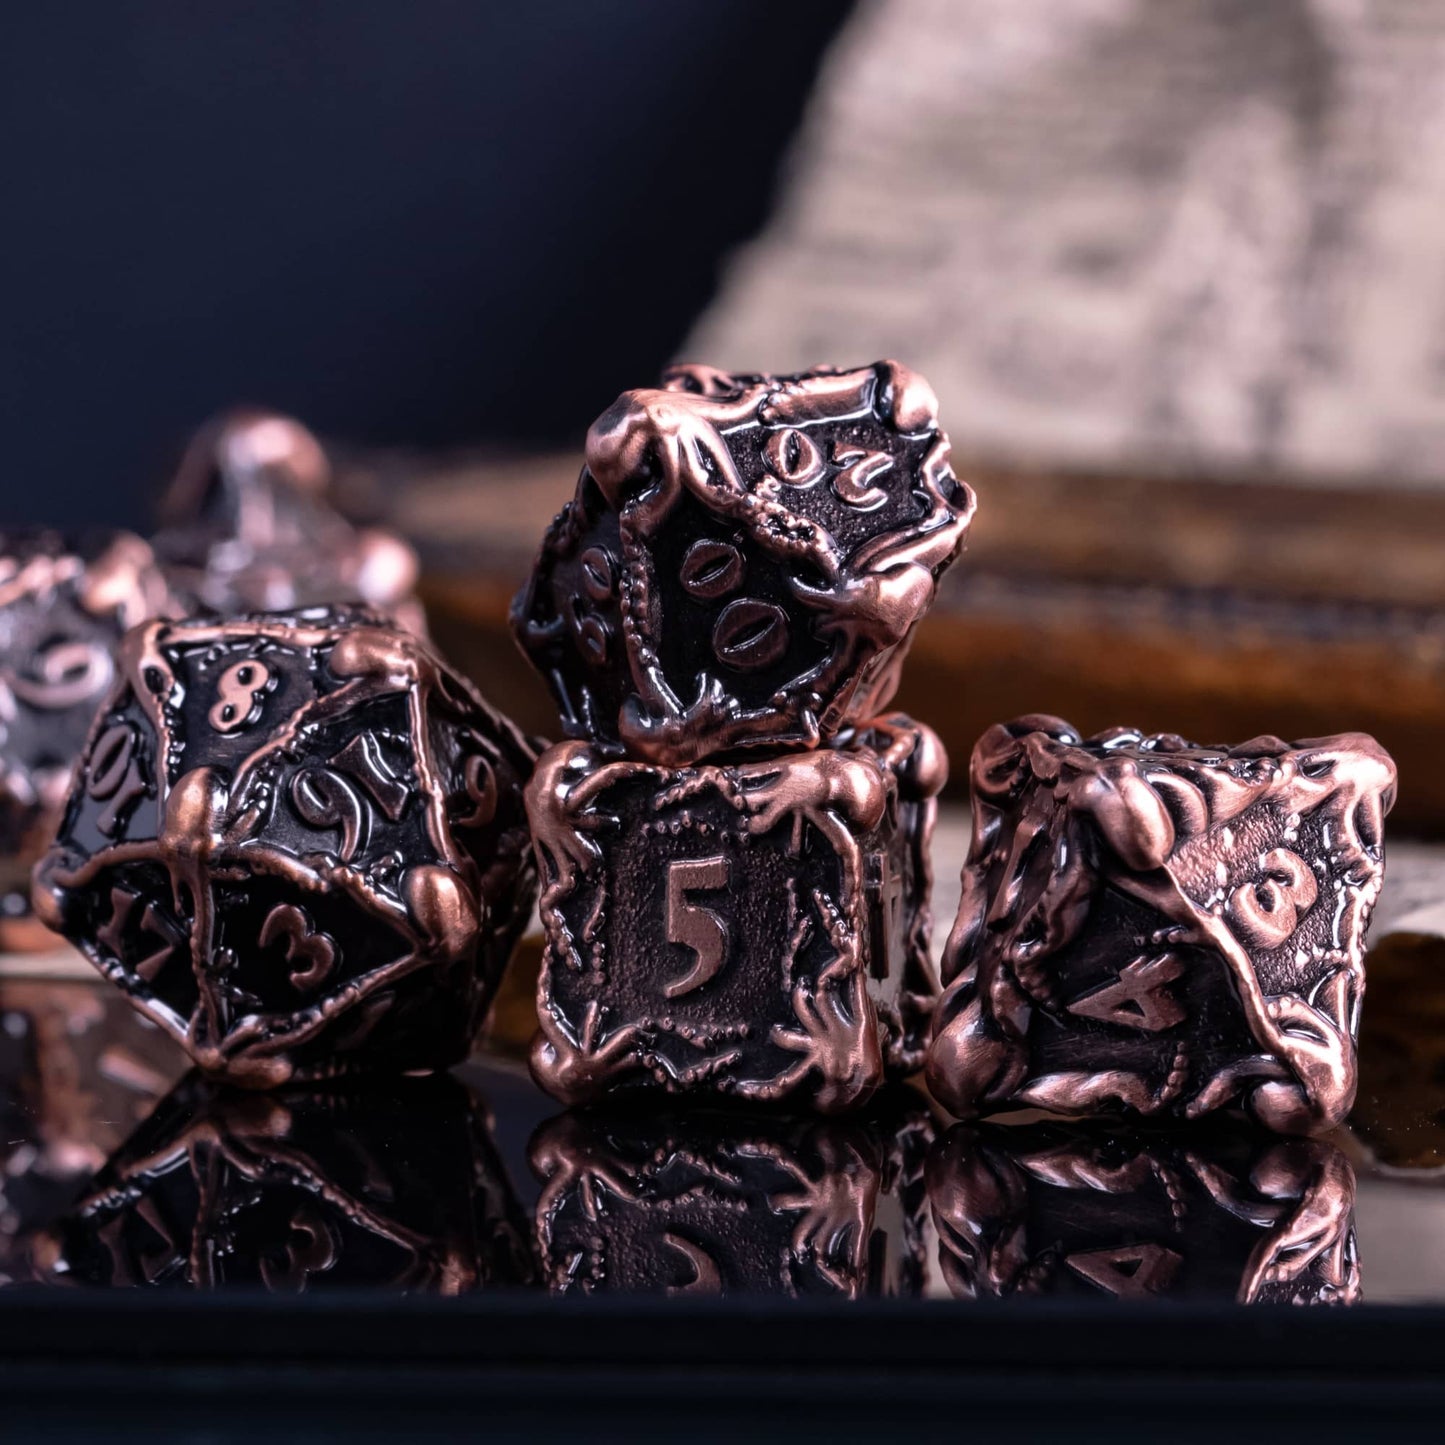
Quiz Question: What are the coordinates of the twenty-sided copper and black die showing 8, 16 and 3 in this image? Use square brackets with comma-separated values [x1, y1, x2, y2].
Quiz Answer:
[35, 608, 535, 1085]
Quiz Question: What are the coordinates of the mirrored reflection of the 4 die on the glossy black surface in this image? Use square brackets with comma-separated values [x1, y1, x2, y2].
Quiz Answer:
[928, 1124, 1360, 1305]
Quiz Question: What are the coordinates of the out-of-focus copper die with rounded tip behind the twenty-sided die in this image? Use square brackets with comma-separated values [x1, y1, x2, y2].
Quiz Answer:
[155, 412, 425, 633]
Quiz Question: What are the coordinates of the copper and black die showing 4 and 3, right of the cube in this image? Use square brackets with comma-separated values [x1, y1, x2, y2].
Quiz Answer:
[928, 717, 1394, 1133]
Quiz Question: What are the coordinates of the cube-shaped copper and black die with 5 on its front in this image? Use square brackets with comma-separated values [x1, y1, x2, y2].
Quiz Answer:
[527, 715, 945, 1111]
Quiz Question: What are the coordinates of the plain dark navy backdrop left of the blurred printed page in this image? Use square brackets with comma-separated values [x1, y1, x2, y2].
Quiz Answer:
[0, 0, 847, 526]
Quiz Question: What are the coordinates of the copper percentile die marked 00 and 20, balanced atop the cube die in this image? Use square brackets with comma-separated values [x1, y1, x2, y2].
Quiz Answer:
[513, 361, 974, 767]
